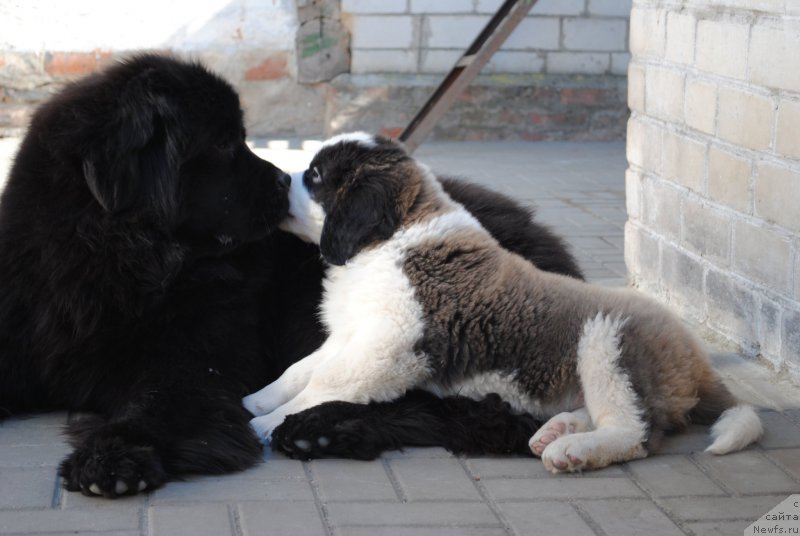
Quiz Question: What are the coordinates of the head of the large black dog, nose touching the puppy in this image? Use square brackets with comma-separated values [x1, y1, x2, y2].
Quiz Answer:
[26, 55, 289, 250]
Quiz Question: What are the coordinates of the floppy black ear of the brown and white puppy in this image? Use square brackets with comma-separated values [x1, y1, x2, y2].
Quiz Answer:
[319, 177, 403, 266]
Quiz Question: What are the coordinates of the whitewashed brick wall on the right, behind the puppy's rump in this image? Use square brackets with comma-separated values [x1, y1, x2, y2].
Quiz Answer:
[624, 0, 800, 382]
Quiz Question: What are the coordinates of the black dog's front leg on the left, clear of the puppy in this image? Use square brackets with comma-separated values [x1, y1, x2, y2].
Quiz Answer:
[59, 379, 262, 498]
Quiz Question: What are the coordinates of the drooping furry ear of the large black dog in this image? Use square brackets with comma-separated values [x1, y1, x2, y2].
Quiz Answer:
[83, 87, 180, 220]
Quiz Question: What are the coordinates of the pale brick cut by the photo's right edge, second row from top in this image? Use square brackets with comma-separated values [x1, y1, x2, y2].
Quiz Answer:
[750, 18, 800, 91]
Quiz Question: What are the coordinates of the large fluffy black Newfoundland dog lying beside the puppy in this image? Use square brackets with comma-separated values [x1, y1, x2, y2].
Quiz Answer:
[0, 55, 580, 497]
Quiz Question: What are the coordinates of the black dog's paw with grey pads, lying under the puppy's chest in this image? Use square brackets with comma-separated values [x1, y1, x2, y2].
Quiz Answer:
[270, 402, 385, 460]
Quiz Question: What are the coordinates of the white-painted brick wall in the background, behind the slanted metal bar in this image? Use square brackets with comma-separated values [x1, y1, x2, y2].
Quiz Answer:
[341, 0, 631, 76]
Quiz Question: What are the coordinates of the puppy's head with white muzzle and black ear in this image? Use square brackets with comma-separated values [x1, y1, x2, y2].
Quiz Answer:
[282, 132, 421, 265]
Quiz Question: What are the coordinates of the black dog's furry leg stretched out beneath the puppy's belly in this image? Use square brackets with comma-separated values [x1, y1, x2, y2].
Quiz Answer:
[272, 391, 541, 460]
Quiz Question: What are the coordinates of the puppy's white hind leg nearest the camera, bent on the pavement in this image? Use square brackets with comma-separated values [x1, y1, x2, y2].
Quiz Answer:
[542, 314, 647, 473]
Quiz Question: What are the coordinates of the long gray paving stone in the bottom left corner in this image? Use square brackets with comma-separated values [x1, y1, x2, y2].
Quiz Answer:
[0, 510, 139, 534]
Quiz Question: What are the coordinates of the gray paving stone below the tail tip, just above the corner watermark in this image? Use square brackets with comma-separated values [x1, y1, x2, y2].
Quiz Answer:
[700, 450, 797, 494]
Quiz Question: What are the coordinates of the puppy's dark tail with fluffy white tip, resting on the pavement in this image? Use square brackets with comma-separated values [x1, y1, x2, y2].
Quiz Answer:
[692, 378, 764, 454]
